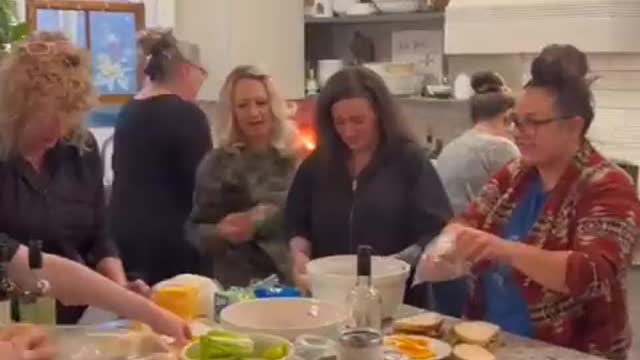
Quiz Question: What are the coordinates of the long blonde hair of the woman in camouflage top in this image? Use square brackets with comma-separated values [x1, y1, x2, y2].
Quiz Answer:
[213, 65, 300, 156]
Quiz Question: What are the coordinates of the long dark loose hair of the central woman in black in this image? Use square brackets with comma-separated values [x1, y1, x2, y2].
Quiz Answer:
[316, 66, 413, 161]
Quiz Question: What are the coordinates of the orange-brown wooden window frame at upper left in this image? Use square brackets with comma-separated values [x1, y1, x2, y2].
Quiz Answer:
[26, 0, 145, 105]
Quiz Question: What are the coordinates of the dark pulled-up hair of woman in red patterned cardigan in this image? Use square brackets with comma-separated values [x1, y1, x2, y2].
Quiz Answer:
[525, 48, 595, 135]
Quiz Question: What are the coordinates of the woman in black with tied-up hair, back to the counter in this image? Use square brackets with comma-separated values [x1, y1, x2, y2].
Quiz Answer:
[110, 30, 211, 284]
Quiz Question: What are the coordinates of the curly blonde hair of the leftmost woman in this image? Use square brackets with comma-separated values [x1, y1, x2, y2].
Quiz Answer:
[0, 32, 97, 160]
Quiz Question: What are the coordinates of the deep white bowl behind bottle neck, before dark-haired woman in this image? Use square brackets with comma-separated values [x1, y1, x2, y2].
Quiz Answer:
[307, 255, 410, 318]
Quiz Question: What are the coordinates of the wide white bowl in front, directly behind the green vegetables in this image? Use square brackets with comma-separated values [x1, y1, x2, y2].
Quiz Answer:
[220, 298, 347, 341]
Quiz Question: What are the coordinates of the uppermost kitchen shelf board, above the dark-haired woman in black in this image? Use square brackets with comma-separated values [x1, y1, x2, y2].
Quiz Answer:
[304, 11, 444, 25]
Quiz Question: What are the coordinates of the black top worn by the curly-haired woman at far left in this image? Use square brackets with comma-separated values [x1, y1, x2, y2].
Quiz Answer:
[0, 137, 118, 267]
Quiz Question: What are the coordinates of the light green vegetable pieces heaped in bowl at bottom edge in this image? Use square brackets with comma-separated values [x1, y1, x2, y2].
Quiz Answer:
[200, 331, 254, 360]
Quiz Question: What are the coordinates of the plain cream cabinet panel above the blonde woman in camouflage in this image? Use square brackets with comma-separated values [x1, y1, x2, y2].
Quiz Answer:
[174, 0, 304, 100]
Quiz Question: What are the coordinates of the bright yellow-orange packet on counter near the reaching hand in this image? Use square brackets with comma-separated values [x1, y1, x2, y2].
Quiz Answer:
[151, 285, 199, 321]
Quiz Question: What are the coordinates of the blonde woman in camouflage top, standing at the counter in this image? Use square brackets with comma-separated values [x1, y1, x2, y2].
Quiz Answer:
[188, 66, 298, 286]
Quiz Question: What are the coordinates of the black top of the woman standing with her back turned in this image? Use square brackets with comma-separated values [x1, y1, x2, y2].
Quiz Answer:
[110, 95, 212, 283]
